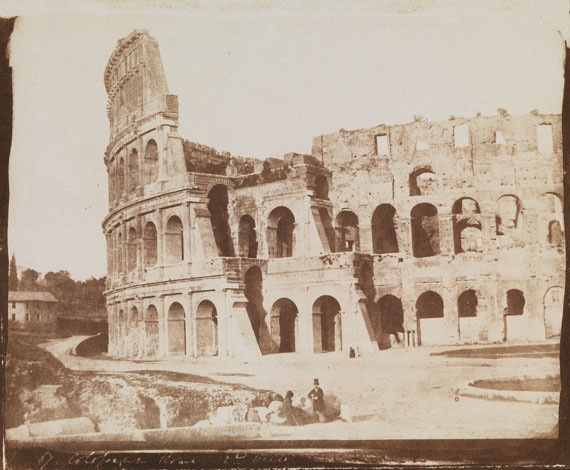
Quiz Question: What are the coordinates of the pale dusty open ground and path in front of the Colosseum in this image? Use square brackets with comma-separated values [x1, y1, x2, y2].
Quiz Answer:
[44, 337, 559, 439]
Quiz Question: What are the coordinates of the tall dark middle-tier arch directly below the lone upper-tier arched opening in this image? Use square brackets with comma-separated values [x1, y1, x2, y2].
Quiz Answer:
[411, 203, 439, 258]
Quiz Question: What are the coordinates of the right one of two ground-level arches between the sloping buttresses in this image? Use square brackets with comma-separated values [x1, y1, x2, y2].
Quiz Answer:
[313, 295, 342, 352]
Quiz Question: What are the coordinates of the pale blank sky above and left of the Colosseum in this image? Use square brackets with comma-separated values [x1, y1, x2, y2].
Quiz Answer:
[0, 0, 568, 279]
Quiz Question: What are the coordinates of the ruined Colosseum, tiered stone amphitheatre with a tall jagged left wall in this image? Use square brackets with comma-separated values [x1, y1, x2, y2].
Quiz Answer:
[103, 30, 564, 358]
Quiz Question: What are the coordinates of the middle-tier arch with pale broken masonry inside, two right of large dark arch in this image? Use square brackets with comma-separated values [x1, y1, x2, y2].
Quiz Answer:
[452, 197, 483, 253]
